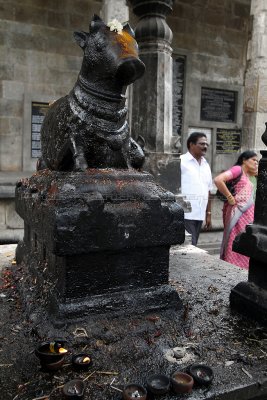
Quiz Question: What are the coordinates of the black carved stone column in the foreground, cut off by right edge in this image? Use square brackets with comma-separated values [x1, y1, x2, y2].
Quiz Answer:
[230, 123, 267, 324]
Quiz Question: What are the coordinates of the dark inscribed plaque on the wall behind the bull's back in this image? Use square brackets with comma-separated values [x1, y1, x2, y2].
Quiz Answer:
[31, 102, 49, 158]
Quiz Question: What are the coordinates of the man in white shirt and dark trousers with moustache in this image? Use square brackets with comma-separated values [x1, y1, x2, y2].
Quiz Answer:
[181, 132, 212, 246]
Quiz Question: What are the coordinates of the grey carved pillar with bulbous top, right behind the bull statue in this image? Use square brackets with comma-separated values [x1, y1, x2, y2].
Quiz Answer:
[128, 0, 180, 193]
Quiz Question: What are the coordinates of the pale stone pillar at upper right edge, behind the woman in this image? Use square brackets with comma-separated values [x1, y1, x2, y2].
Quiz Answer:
[243, 0, 267, 151]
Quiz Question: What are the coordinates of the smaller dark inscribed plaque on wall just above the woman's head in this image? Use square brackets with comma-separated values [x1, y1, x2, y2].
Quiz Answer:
[216, 128, 241, 154]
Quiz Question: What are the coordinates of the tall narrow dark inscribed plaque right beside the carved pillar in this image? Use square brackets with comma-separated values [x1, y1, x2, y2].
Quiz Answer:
[172, 56, 185, 136]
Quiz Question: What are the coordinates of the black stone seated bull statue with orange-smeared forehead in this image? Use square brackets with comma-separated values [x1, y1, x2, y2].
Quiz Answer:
[37, 15, 145, 171]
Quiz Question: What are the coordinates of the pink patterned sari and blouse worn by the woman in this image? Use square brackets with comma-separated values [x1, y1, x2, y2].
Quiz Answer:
[220, 165, 254, 269]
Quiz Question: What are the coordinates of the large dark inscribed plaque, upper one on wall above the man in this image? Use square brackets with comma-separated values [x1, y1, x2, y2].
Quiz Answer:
[200, 87, 237, 122]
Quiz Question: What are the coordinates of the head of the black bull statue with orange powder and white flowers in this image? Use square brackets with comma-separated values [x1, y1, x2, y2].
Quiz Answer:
[74, 15, 145, 91]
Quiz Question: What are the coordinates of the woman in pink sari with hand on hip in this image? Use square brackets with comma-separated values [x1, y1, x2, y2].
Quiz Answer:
[214, 150, 258, 269]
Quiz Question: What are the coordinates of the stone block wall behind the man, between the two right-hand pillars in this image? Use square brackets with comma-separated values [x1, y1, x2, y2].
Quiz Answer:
[168, 0, 251, 174]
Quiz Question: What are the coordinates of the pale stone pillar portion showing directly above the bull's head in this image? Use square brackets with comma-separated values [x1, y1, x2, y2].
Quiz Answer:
[101, 0, 129, 23]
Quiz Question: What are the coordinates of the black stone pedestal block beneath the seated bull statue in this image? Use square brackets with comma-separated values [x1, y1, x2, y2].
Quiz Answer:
[16, 169, 184, 320]
